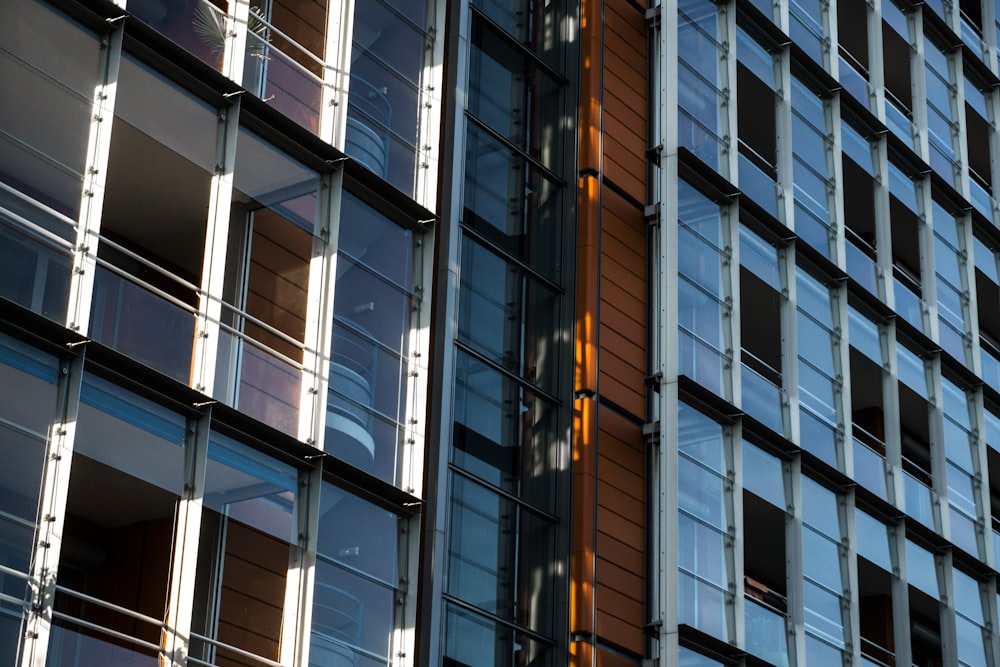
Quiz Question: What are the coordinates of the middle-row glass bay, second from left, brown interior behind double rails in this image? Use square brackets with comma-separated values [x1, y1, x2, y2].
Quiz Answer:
[90, 56, 221, 384]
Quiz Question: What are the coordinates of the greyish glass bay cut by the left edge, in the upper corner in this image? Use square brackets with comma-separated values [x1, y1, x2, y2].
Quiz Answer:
[0, 0, 101, 323]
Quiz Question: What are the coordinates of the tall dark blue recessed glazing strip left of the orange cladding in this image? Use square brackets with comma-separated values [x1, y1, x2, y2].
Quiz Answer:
[444, 1, 569, 665]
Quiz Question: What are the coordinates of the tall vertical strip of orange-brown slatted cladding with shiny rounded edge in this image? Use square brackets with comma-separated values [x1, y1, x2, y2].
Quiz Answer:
[571, 0, 647, 667]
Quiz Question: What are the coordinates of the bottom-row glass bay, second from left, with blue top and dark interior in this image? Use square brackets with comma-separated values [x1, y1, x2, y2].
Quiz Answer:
[49, 376, 186, 664]
